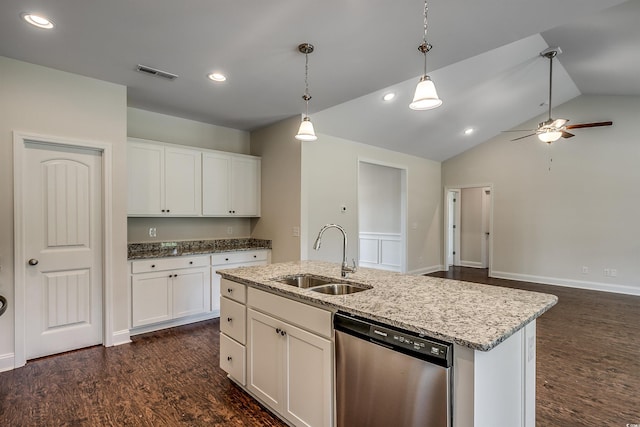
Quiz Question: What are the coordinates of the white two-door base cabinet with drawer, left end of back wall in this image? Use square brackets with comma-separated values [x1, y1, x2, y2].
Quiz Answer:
[131, 256, 211, 329]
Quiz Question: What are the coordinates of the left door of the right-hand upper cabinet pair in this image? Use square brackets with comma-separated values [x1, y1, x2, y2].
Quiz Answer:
[202, 153, 231, 216]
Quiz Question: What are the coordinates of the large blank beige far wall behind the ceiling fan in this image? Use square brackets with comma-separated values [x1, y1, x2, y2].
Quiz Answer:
[442, 95, 640, 294]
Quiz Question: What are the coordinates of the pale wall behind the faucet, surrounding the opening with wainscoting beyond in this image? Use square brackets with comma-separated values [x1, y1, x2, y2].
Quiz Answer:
[301, 134, 443, 273]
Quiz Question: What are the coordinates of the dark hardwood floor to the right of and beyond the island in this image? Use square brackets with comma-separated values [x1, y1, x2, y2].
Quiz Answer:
[431, 267, 640, 427]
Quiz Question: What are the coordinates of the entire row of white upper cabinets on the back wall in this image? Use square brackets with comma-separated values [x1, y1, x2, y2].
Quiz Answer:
[127, 138, 260, 217]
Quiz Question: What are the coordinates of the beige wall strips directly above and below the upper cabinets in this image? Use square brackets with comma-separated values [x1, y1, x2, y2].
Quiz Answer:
[127, 108, 251, 242]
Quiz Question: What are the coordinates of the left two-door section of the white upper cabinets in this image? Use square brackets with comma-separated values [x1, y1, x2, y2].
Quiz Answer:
[127, 139, 202, 216]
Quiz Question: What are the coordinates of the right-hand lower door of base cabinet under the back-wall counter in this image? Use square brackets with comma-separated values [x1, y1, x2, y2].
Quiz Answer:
[172, 267, 211, 318]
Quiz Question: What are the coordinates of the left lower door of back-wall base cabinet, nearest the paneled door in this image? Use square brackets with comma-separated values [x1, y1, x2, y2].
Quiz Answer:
[131, 271, 172, 328]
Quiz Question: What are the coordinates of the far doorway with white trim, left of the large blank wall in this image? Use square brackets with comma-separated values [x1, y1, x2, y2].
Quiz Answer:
[444, 185, 493, 274]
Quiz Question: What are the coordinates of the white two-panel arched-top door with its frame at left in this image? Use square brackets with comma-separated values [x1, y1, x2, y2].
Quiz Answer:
[14, 134, 111, 367]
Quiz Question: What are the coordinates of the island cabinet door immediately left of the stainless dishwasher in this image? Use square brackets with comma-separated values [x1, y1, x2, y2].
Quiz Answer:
[283, 325, 333, 427]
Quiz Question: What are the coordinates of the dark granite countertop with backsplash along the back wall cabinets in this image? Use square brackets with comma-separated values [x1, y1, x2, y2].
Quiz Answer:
[127, 238, 271, 260]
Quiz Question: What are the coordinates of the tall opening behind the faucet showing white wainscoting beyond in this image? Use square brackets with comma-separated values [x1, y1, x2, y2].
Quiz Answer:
[358, 160, 407, 273]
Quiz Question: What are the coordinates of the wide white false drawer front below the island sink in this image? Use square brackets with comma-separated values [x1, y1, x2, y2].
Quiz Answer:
[247, 288, 332, 338]
